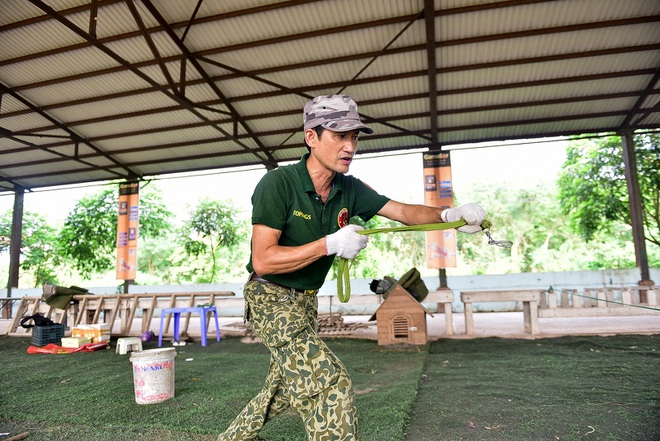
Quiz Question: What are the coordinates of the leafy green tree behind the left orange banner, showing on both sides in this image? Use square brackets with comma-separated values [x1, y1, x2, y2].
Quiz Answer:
[58, 186, 172, 278]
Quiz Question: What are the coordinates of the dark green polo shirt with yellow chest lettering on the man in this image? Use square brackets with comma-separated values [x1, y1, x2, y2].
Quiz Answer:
[247, 154, 389, 289]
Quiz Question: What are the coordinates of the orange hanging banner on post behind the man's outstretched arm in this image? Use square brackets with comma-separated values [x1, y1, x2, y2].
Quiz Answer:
[423, 150, 456, 268]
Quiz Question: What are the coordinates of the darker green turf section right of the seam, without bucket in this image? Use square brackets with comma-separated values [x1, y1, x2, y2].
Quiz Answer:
[407, 336, 660, 441]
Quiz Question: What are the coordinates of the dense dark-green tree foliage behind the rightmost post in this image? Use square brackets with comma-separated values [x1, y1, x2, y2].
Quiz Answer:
[559, 133, 660, 246]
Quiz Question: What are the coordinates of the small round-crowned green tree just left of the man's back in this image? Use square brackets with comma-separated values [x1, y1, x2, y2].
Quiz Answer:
[182, 199, 247, 283]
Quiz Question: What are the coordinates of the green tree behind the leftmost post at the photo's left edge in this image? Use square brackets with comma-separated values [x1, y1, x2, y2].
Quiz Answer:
[0, 211, 58, 288]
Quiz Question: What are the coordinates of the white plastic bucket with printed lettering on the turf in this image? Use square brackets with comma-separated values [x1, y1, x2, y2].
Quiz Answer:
[131, 348, 176, 404]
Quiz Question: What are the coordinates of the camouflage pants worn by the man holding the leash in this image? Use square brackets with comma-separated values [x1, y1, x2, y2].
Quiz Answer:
[218, 281, 358, 441]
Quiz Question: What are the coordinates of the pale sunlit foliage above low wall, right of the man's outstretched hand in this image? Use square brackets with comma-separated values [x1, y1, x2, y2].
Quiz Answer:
[448, 180, 660, 275]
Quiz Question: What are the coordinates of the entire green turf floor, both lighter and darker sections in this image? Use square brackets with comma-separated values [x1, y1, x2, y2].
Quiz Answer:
[0, 336, 660, 441]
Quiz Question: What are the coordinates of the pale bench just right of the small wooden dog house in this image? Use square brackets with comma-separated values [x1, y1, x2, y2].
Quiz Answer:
[461, 289, 543, 335]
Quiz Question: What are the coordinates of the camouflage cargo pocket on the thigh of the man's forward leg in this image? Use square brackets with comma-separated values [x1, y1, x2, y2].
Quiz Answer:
[271, 329, 341, 400]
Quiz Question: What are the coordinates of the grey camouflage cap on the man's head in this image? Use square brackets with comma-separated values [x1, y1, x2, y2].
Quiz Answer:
[303, 95, 374, 134]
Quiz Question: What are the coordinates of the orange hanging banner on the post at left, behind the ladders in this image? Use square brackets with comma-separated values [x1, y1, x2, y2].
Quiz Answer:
[117, 182, 140, 280]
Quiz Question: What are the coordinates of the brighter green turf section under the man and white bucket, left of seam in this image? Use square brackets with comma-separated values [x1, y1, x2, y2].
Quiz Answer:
[0, 337, 427, 441]
